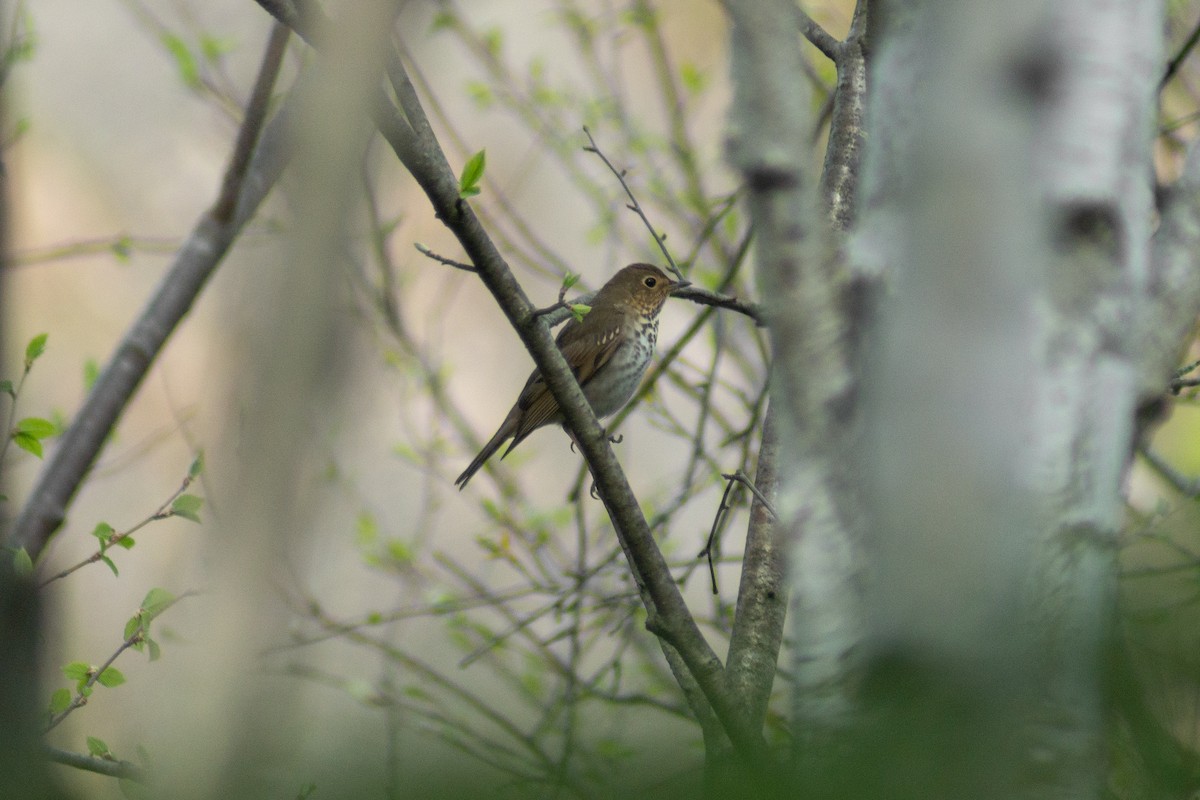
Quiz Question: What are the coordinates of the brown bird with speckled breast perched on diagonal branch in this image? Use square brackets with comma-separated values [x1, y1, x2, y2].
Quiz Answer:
[455, 264, 690, 489]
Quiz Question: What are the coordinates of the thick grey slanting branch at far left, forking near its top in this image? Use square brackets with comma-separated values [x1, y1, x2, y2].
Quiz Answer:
[8, 20, 290, 560]
